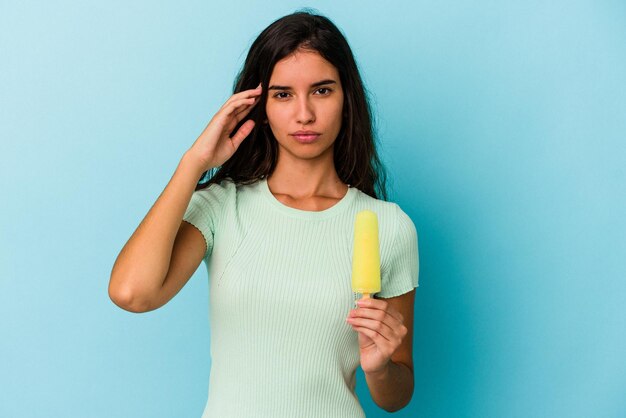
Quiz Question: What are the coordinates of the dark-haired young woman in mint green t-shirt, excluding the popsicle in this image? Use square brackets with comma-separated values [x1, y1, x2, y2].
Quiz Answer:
[109, 12, 418, 418]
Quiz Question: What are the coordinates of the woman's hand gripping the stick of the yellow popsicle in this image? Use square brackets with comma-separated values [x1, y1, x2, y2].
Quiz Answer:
[346, 299, 408, 373]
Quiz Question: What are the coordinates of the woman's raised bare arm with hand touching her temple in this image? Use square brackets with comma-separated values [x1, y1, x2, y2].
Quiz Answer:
[109, 83, 261, 312]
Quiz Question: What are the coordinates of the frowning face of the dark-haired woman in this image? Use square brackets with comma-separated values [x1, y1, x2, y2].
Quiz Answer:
[265, 50, 343, 163]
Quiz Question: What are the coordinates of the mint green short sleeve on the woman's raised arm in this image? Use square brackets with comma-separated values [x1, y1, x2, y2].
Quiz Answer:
[183, 183, 227, 258]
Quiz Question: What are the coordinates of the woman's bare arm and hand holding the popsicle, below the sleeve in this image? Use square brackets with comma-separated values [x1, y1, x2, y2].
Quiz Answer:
[346, 289, 415, 412]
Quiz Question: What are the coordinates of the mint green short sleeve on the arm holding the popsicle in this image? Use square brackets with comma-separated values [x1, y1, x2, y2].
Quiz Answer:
[376, 205, 419, 298]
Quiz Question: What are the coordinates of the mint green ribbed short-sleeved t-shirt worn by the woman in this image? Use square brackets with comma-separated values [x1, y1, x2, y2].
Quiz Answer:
[183, 179, 418, 418]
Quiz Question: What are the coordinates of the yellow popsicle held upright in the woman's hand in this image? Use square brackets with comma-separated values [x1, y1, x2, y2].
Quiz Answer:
[352, 210, 380, 299]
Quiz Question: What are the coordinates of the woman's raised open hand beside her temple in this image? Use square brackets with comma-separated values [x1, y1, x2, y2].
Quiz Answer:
[186, 84, 262, 172]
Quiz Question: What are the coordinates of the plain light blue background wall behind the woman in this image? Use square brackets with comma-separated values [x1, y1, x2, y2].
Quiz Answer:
[0, 0, 626, 418]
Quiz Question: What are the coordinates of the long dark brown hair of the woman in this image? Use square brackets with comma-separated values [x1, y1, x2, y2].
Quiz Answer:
[196, 9, 387, 200]
